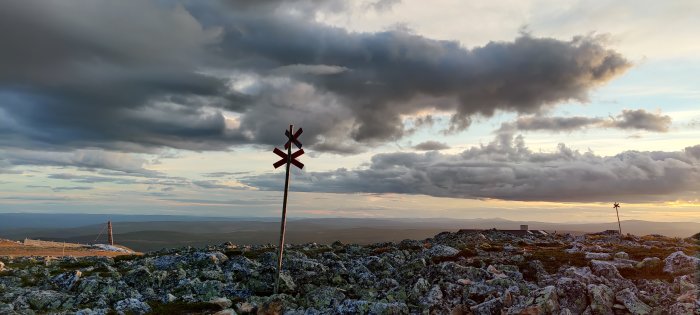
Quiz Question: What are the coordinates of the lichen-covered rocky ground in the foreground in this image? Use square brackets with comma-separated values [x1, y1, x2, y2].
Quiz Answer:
[0, 230, 700, 314]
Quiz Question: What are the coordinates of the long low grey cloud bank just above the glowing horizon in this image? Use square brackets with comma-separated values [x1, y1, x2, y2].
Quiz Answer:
[243, 134, 700, 202]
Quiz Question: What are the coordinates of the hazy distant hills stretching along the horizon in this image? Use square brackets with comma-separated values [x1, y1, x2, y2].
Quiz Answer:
[0, 214, 700, 251]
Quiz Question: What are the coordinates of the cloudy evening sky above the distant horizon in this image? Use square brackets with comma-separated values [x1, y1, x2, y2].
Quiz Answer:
[0, 0, 700, 222]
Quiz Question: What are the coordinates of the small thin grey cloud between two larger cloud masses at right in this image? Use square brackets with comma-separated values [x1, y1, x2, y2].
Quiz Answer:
[499, 109, 671, 132]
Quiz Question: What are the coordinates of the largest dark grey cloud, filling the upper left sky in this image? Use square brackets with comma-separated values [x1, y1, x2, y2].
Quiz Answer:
[0, 0, 630, 153]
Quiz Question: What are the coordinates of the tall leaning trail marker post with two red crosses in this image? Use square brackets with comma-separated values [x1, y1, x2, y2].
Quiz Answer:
[272, 125, 304, 294]
